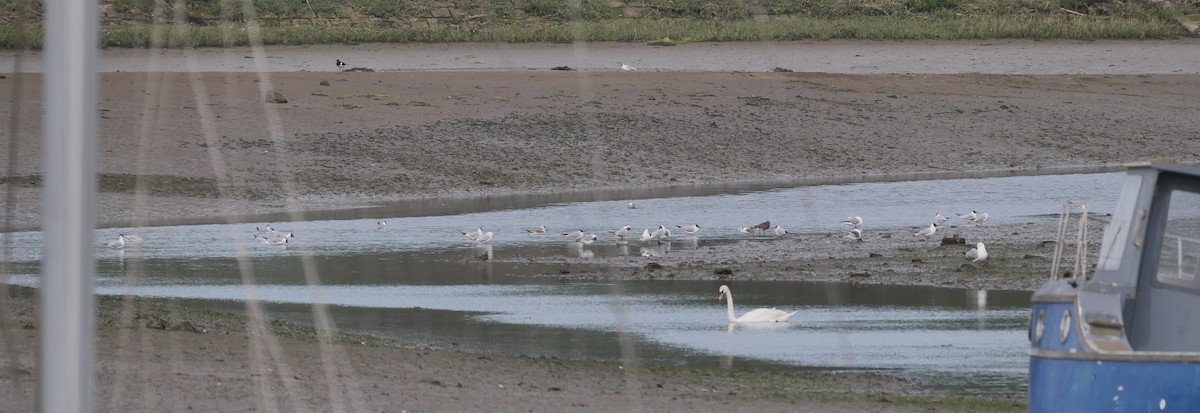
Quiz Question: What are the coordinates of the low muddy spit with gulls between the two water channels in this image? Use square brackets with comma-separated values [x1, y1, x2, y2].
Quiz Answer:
[520, 214, 1104, 291]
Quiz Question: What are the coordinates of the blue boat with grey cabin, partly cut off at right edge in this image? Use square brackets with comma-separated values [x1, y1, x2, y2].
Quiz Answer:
[1028, 163, 1200, 413]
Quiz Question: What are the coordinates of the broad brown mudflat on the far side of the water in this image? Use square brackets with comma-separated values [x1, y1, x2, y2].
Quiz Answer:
[0, 71, 1200, 228]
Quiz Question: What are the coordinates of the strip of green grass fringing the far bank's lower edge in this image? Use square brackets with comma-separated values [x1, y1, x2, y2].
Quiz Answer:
[70, 16, 1187, 49]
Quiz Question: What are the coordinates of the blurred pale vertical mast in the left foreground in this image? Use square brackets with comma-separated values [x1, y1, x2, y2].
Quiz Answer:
[39, 0, 98, 412]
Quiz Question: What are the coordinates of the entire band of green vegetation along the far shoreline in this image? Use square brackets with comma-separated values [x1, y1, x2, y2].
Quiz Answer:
[0, 0, 1200, 49]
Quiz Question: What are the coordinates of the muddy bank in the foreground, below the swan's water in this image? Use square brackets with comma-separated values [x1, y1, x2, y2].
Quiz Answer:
[0, 287, 1022, 412]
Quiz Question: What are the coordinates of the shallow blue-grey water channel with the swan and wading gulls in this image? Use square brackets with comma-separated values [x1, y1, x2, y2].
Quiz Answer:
[5, 173, 1122, 394]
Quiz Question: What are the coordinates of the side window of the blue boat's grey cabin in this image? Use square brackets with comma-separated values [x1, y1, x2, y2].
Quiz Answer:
[1158, 190, 1200, 289]
